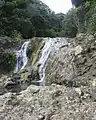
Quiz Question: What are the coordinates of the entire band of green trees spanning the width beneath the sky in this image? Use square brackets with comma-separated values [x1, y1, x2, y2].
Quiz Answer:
[0, 0, 96, 40]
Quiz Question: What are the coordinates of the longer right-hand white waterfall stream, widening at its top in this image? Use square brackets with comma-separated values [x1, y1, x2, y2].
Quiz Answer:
[37, 38, 68, 85]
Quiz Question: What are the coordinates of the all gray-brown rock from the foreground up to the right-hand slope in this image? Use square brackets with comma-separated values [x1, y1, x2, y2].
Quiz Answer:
[0, 34, 96, 120]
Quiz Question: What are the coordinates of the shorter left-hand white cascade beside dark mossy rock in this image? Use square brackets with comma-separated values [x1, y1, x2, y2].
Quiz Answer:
[14, 41, 30, 73]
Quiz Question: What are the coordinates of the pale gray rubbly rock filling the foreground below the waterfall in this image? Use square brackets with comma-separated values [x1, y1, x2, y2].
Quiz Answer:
[0, 84, 96, 120]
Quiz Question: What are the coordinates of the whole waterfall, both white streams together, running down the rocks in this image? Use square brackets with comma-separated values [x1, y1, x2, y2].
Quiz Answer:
[14, 38, 68, 85]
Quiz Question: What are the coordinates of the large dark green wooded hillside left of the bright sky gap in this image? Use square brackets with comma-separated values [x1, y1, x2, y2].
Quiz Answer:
[0, 0, 64, 38]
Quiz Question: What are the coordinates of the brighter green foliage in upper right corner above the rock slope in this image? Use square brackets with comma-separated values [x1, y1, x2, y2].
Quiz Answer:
[77, 0, 96, 34]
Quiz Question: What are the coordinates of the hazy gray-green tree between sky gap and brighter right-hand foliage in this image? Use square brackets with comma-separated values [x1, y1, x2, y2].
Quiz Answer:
[60, 9, 78, 37]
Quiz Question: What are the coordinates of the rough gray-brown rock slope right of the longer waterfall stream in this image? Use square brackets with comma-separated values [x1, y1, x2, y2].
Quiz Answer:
[45, 34, 96, 87]
